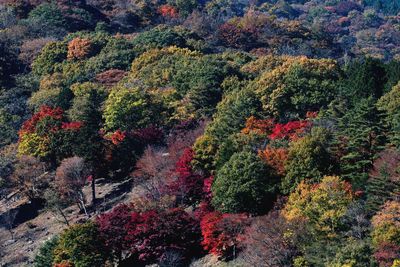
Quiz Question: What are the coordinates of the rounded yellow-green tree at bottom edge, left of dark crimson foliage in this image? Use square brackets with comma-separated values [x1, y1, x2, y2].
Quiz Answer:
[53, 222, 109, 267]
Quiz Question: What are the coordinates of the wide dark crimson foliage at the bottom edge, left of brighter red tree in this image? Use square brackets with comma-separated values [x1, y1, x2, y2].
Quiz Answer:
[97, 205, 200, 263]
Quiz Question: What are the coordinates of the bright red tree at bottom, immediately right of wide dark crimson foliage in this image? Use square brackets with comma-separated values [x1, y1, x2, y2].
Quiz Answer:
[200, 212, 249, 260]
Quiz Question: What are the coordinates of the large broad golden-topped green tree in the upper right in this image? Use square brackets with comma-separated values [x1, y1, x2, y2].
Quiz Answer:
[252, 57, 340, 120]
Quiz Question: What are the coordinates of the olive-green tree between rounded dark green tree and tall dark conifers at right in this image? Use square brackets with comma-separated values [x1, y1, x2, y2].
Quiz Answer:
[282, 128, 333, 193]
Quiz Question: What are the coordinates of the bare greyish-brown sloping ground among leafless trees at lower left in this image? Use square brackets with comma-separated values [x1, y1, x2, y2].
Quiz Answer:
[0, 180, 131, 267]
